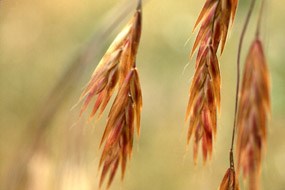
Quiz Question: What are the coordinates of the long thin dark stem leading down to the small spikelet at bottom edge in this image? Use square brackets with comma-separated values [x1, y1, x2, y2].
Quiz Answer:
[230, 0, 256, 170]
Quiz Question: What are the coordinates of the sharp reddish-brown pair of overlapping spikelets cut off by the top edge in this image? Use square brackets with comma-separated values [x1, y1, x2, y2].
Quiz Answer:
[186, 0, 237, 163]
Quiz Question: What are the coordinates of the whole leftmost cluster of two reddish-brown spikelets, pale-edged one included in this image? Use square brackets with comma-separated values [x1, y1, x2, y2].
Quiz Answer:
[77, 1, 142, 188]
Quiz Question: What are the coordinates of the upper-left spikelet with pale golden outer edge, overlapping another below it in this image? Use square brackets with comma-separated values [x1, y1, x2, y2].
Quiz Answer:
[79, 4, 141, 118]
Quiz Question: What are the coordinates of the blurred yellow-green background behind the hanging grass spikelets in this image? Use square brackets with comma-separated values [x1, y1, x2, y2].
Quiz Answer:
[0, 0, 285, 190]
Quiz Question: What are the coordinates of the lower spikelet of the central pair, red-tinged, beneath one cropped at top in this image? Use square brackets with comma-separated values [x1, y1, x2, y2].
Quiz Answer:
[187, 47, 220, 162]
